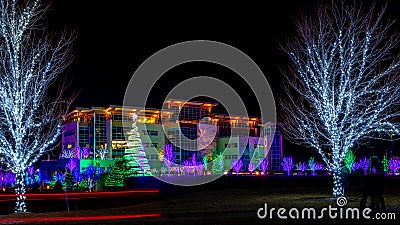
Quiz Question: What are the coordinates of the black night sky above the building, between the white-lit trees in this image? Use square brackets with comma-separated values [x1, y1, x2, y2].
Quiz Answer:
[47, 0, 400, 158]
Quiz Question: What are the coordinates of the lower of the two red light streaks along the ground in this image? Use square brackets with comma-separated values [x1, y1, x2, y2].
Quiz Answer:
[2, 214, 161, 223]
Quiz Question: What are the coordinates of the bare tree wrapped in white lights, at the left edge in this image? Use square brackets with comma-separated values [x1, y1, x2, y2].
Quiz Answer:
[0, 0, 72, 212]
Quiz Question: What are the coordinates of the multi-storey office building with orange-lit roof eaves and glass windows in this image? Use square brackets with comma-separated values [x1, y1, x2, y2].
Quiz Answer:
[60, 100, 283, 171]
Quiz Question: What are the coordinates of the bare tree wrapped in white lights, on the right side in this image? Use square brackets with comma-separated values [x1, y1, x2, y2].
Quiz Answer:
[281, 1, 400, 196]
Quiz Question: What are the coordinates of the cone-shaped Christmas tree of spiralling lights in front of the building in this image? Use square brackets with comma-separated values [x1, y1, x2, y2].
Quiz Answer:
[124, 113, 151, 176]
